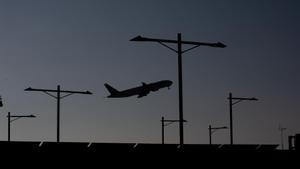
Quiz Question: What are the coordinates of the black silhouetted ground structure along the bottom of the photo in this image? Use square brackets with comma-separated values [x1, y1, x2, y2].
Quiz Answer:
[0, 141, 299, 168]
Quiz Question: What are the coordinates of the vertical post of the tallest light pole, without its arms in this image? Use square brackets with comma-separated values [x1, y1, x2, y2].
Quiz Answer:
[177, 33, 184, 146]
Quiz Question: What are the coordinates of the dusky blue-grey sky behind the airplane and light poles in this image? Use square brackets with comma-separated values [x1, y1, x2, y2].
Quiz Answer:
[0, 0, 300, 147]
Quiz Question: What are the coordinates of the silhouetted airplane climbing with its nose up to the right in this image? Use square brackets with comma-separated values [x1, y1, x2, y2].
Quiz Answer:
[104, 80, 173, 98]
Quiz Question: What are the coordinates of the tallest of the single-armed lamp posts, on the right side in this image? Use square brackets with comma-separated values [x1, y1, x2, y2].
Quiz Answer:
[228, 93, 258, 145]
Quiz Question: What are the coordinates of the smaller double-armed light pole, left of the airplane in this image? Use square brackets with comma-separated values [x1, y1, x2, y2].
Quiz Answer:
[25, 85, 92, 143]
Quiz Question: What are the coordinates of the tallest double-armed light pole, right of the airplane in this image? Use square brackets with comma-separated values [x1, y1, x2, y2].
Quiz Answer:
[130, 33, 226, 146]
